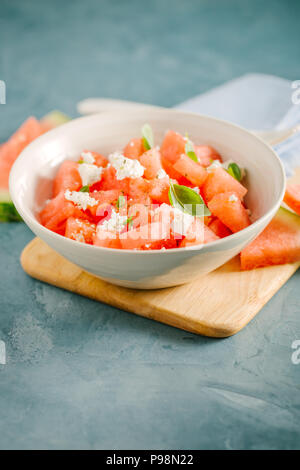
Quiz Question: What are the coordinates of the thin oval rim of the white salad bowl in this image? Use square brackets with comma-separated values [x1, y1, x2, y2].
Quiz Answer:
[9, 105, 286, 256]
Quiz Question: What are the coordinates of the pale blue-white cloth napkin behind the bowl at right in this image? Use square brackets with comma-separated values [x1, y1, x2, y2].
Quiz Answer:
[176, 74, 300, 176]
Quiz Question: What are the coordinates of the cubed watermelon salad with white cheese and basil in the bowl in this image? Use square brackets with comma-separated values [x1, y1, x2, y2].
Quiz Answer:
[40, 125, 251, 250]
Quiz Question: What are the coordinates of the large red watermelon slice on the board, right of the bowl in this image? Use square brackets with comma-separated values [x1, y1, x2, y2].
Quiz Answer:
[240, 207, 300, 270]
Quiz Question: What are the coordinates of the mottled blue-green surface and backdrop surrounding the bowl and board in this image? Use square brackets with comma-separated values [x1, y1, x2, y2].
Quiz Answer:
[0, 0, 300, 449]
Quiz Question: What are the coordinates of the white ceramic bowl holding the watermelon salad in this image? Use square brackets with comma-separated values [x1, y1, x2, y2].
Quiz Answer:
[10, 107, 285, 289]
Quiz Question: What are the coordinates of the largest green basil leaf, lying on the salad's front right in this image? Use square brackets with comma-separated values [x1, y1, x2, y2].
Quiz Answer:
[169, 183, 211, 217]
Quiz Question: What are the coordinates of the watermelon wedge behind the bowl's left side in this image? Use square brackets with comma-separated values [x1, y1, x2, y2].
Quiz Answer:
[0, 111, 70, 222]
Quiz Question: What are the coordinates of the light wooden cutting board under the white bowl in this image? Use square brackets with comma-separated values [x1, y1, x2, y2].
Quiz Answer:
[21, 238, 299, 338]
